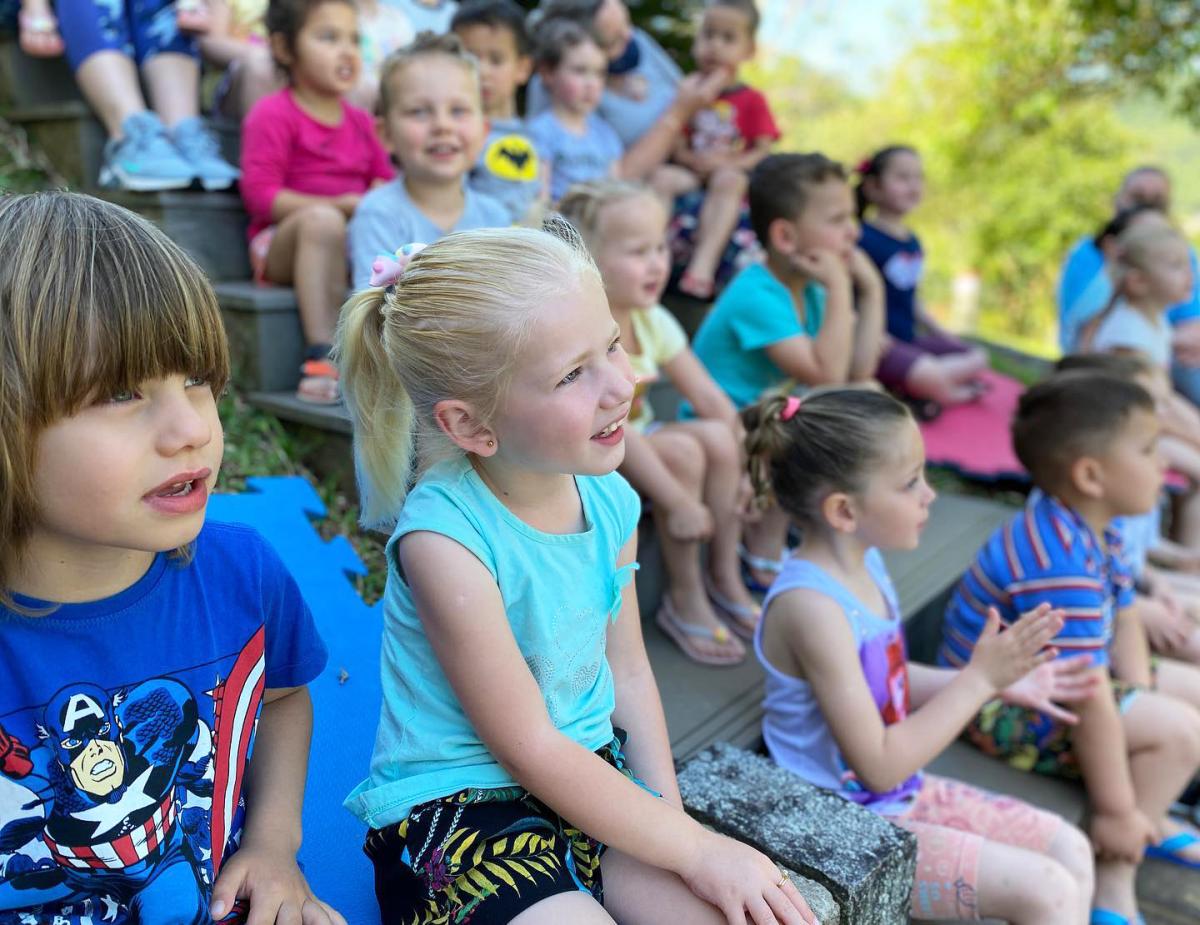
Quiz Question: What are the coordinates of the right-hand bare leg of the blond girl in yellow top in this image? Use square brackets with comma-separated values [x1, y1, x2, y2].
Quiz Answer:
[670, 421, 758, 629]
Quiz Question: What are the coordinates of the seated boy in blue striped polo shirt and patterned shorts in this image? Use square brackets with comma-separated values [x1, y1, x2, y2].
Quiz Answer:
[938, 371, 1200, 925]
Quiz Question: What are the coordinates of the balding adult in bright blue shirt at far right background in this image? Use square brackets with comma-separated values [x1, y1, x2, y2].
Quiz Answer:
[1058, 164, 1200, 404]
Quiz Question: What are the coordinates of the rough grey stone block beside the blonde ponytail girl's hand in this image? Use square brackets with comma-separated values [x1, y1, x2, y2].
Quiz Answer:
[679, 743, 917, 925]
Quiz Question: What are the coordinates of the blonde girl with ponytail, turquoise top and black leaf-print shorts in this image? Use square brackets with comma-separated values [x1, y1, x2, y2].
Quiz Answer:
[337, 221, 812, 925]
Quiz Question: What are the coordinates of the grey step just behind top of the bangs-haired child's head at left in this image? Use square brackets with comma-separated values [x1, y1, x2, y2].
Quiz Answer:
[100, 190, 250, 281]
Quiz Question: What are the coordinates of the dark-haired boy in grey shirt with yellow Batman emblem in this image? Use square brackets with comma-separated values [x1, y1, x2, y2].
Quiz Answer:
[450, 0, 542, 224]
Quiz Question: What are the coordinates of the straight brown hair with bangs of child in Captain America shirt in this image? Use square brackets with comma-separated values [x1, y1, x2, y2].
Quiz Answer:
[0, 192, 229, 605]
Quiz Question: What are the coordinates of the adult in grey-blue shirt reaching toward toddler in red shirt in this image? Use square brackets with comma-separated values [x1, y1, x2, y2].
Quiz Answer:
[526, 0, 724, 179]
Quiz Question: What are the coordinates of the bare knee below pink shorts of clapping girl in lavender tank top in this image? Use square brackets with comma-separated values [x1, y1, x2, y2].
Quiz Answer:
[978, 840, 1091, 925]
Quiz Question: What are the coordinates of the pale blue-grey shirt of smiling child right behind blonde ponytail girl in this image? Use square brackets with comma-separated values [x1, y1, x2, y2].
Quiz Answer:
[346, 176, 511, 289]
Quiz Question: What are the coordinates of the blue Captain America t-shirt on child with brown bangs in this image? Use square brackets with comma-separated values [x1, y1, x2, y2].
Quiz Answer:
[0, 523, 328, 925]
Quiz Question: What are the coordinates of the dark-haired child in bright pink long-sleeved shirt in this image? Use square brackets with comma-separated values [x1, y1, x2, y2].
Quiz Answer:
[241, 0, 394, 404]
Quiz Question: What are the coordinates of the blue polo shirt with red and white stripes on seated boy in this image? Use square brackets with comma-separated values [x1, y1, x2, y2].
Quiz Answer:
[937, 489, 1134, 668]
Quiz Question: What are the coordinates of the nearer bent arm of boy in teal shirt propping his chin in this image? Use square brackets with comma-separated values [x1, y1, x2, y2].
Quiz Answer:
[767, 251, 854, 385]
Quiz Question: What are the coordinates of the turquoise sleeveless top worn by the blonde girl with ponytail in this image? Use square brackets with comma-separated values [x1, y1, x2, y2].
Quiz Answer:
[346, 457, 641, 828]
